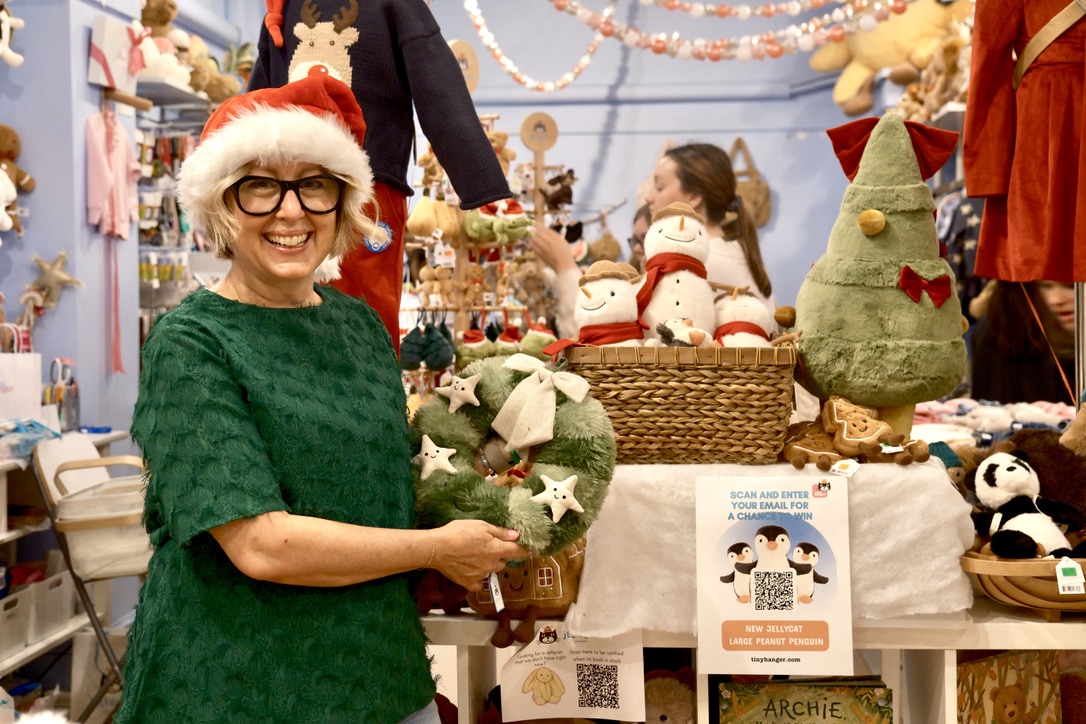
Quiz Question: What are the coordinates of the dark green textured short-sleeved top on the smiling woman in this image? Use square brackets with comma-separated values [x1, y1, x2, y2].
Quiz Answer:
[115, 287, 434, 724]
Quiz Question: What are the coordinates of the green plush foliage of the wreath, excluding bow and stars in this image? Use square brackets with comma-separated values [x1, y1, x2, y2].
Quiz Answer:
[411, 357, 616, 555]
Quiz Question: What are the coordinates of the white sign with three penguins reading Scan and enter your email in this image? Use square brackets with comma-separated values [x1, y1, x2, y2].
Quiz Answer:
[695, 475, 853, 675]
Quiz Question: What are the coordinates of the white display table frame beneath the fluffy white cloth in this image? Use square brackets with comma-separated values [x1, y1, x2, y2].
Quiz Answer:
[422, 597, 1086, 724]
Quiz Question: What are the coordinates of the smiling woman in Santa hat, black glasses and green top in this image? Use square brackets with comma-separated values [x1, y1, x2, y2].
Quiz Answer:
[116, 75, 529, 723]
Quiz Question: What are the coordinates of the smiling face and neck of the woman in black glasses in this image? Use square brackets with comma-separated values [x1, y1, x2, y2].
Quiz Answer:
[226, 163, 339, 304]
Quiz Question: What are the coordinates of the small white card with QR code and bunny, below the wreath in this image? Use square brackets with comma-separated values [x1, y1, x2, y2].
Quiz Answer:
[500, 621, 645, 722]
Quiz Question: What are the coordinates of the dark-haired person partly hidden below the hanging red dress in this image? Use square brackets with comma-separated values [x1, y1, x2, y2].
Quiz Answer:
[970, 281, 1075, 404]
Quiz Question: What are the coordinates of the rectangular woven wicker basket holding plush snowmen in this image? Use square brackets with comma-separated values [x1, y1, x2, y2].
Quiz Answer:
[566, 345, 796, 465]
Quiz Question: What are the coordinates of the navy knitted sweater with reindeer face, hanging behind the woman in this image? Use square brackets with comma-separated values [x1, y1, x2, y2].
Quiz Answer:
[249, 0, 513, 208]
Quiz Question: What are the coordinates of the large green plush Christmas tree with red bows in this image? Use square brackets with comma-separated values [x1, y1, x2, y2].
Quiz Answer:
[796, 113, 965, 434]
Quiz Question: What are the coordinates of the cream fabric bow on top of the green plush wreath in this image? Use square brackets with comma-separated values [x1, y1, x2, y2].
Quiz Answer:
[490, 353, 589, 453]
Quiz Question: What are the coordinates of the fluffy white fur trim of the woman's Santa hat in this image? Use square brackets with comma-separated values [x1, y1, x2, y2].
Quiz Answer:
[177, 104, 374, 228]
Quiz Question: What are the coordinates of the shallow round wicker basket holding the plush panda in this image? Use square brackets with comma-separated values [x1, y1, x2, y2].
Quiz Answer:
[961, 546, 1086, 619]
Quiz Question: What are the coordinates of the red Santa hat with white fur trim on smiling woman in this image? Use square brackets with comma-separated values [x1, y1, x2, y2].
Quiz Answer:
[177, 73, 374, 235]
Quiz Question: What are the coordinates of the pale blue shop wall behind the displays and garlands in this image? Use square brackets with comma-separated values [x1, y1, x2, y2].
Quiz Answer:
[0, 0, 860, 428]
